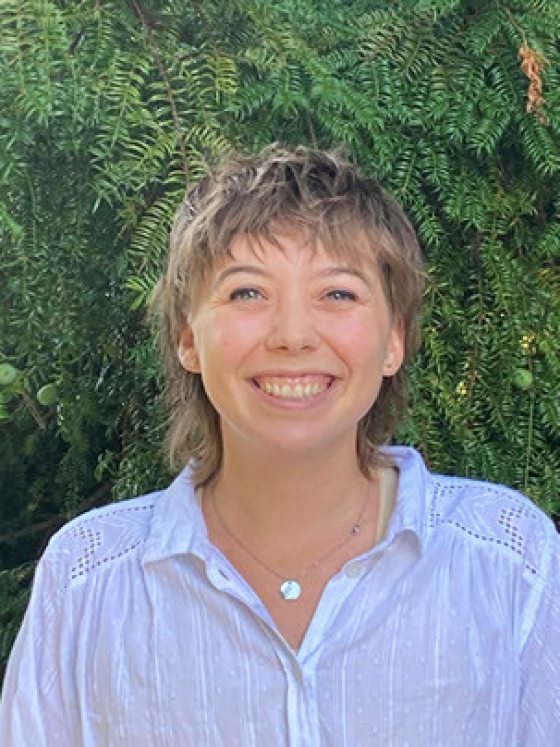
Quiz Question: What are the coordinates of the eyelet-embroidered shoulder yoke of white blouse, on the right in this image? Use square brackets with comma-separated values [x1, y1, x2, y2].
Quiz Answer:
[427, 474, 559, 584]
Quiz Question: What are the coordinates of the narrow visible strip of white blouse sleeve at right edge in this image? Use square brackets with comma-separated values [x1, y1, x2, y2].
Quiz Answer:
[519, 532, 560, 747]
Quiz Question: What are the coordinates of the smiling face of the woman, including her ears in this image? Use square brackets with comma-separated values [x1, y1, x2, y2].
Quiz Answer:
[179, 235, 403, 457]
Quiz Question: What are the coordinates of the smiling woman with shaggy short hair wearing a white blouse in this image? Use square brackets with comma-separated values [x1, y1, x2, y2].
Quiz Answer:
[0, 146, 560, 747]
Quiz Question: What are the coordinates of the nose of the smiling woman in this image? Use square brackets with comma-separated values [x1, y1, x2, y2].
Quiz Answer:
[266, 294, 318, 353]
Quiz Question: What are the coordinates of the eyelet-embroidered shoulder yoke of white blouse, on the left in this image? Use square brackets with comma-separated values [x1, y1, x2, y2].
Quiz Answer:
[40, 491, 162, 592]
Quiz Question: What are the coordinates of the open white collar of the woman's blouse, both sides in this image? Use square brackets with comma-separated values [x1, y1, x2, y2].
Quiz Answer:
[143, 446, 431, 563]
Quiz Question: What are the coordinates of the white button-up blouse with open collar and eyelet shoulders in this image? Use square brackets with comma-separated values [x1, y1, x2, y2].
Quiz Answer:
[0, 447, 560, 747]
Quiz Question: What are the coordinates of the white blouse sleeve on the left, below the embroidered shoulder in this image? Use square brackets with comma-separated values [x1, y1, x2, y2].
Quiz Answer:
[0, 548, 81, 747]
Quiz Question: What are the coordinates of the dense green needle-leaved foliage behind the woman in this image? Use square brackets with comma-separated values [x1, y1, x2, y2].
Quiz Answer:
[0, 0, 560, 676]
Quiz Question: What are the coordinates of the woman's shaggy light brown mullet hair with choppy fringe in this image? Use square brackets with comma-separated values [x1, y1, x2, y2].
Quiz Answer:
[155, 145, 424, 485]
